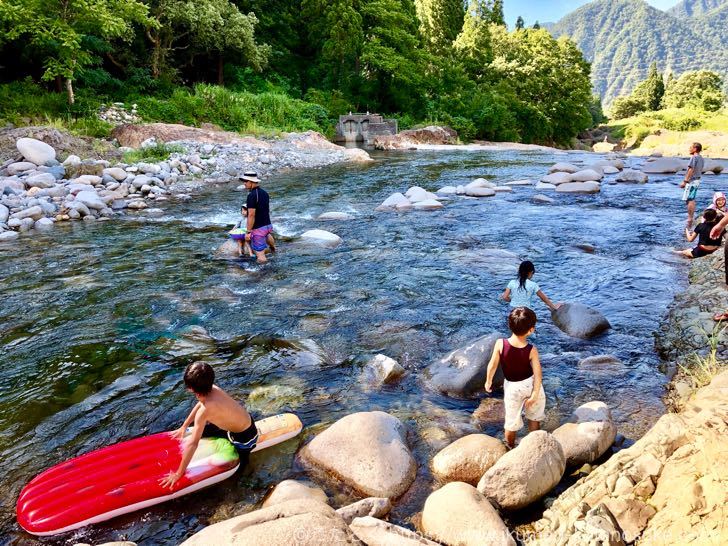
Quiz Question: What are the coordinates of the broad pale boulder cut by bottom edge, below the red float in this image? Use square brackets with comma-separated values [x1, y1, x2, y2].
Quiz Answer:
[182, 499, 363, 546]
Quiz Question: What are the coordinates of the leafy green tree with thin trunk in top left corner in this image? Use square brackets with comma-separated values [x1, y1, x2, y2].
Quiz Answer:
[0, 0, 153, 104]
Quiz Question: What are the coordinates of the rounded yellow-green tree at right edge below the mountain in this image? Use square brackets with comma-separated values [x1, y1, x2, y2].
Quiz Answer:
[664, 70, 726, 112]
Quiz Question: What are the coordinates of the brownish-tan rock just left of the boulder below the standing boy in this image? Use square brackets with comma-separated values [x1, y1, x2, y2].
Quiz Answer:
[432, 434, 507, 485]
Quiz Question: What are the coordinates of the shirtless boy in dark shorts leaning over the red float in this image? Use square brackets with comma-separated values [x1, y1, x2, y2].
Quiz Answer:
[159, 362, 258, 489]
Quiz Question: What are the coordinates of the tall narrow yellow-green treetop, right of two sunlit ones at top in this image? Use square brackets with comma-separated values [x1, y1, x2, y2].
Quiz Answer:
[453, 0, 493, 80]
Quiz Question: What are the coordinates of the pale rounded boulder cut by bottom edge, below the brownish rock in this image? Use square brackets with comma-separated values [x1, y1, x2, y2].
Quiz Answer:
[421, 482, 516, 546]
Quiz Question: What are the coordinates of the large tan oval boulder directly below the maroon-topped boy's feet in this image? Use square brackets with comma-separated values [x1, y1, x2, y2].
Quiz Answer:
[478, 430, 566, 510]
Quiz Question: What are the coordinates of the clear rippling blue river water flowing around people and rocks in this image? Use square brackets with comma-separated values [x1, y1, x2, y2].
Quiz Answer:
[0, 147, 720, 545]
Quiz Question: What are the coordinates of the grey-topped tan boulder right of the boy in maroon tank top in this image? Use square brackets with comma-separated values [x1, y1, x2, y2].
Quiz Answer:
[553, 401, 617, 466]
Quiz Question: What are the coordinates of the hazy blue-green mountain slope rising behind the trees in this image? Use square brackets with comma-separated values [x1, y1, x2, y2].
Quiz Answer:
[551, 0, 728, 103]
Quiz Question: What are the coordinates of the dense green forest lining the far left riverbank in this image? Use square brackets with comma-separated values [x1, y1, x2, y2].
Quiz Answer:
[0, 0, 598, 143]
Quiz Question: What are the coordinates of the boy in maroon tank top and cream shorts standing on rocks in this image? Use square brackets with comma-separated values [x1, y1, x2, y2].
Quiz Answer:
[485, 307, 546, 448]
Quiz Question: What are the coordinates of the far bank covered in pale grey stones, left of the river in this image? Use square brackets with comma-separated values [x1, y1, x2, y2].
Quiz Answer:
[0, 124, 370, 241]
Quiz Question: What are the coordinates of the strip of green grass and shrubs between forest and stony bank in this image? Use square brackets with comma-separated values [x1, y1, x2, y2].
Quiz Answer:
[0, 82, 335, 138]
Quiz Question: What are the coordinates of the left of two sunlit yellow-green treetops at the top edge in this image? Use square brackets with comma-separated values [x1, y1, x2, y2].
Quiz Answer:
[415, 0, 465, 53]
